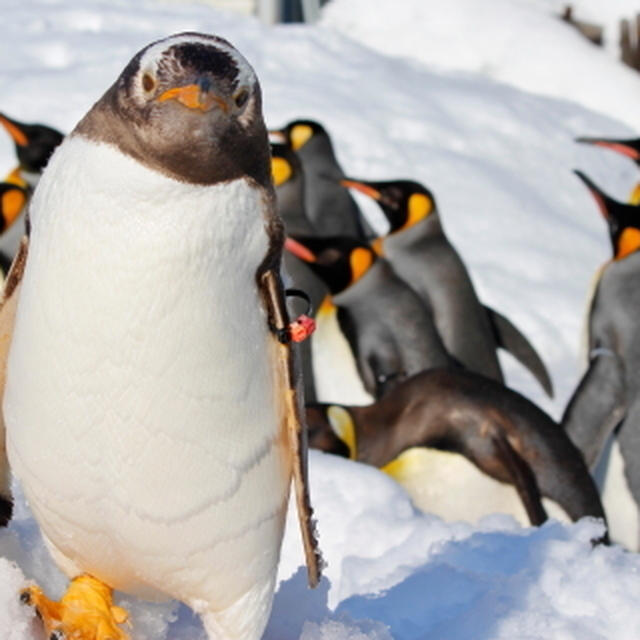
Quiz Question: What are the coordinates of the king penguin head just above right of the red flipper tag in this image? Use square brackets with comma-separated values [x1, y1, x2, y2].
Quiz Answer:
[285, 236, 377, 295]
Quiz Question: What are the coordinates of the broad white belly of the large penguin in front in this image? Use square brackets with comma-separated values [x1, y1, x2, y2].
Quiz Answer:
[4, 139, 290, 609]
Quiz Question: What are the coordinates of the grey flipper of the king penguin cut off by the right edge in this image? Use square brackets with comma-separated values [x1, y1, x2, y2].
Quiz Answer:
[561, 349, 627, 469]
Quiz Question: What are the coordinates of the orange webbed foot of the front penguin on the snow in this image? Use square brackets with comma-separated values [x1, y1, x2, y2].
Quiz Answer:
[20, 574, 129, 640]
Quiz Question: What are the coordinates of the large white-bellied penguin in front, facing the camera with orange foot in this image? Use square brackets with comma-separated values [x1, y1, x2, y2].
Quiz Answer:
[0, 33, 319, 640]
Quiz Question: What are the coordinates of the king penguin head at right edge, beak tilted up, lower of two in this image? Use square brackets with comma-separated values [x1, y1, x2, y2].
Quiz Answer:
[575, 171, 640, 260]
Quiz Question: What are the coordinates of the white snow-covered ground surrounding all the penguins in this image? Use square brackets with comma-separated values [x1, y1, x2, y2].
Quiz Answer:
[0, 0, 640, 640]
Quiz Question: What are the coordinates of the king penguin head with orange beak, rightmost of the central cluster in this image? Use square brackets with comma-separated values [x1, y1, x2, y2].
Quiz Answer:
[340, 178, 436, 234]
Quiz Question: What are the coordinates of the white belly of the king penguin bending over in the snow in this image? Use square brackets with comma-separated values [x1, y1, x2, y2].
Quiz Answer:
[384, 448, 570, 526]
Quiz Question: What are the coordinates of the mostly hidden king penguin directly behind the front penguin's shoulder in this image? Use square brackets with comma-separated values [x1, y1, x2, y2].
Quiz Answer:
[271, 143, 329, 402]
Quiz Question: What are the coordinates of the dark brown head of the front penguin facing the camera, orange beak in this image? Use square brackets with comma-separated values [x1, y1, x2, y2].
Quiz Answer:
[74, 33, 271, 186]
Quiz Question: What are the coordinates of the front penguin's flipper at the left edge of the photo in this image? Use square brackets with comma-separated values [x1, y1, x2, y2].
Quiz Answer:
[0, 236, 29, 527]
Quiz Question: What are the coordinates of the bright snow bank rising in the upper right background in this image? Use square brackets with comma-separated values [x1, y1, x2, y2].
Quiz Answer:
[321, 0, 640, 129]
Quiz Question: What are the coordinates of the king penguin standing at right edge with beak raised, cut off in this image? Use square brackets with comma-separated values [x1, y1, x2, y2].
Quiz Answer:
[562, 171, 640, 550]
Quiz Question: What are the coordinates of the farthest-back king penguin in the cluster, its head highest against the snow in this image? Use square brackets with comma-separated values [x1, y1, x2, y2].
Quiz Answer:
[271, 120, 372, 238]
